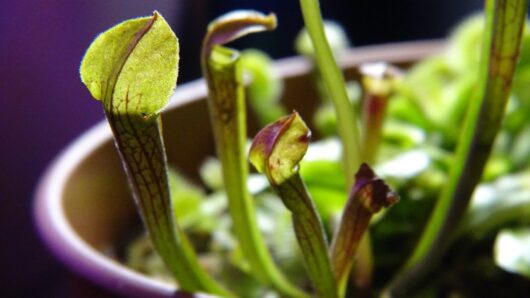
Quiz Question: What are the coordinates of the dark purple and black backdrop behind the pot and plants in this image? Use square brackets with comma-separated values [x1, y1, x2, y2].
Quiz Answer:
[0, 0, 482, 297]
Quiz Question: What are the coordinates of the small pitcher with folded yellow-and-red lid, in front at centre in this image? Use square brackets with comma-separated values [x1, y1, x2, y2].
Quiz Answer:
[249, 112, 338, 297]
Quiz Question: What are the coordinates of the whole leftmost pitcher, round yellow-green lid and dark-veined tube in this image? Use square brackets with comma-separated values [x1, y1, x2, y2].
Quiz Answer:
[80, 12, 231, 296]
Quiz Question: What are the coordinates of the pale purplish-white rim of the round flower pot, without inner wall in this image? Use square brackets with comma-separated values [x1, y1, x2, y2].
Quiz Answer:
[33, 40, 444, 297]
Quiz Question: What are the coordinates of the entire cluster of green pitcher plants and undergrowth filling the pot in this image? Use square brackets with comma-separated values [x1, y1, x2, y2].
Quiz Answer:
[81, 0, 530, 297]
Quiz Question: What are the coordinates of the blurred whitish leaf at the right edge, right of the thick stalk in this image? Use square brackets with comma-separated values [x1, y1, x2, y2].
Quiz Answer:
[494, 227, 530, 279]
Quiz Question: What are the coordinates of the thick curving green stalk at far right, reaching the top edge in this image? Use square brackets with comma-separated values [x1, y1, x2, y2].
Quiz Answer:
[387, 0, 528, 297]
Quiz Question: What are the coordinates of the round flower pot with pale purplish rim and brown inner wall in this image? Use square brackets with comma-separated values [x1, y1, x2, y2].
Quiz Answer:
[34, 41, 442, 297]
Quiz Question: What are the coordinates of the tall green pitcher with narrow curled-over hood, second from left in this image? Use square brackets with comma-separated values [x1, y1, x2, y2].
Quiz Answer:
[201, 11, 306, 297]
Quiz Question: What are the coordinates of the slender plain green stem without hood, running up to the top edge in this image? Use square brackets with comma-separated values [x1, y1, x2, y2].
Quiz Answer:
[300, 0, 361, 181]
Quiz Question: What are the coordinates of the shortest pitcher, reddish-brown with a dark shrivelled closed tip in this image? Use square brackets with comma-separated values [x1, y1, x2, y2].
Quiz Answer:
[331, 163, 399, 294]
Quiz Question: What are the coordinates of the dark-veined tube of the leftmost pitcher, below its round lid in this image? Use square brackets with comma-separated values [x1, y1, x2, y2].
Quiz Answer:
[105, 111, 231, 296]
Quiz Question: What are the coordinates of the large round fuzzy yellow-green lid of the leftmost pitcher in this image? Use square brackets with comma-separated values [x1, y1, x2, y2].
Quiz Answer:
[80, 11, 179, 117]
